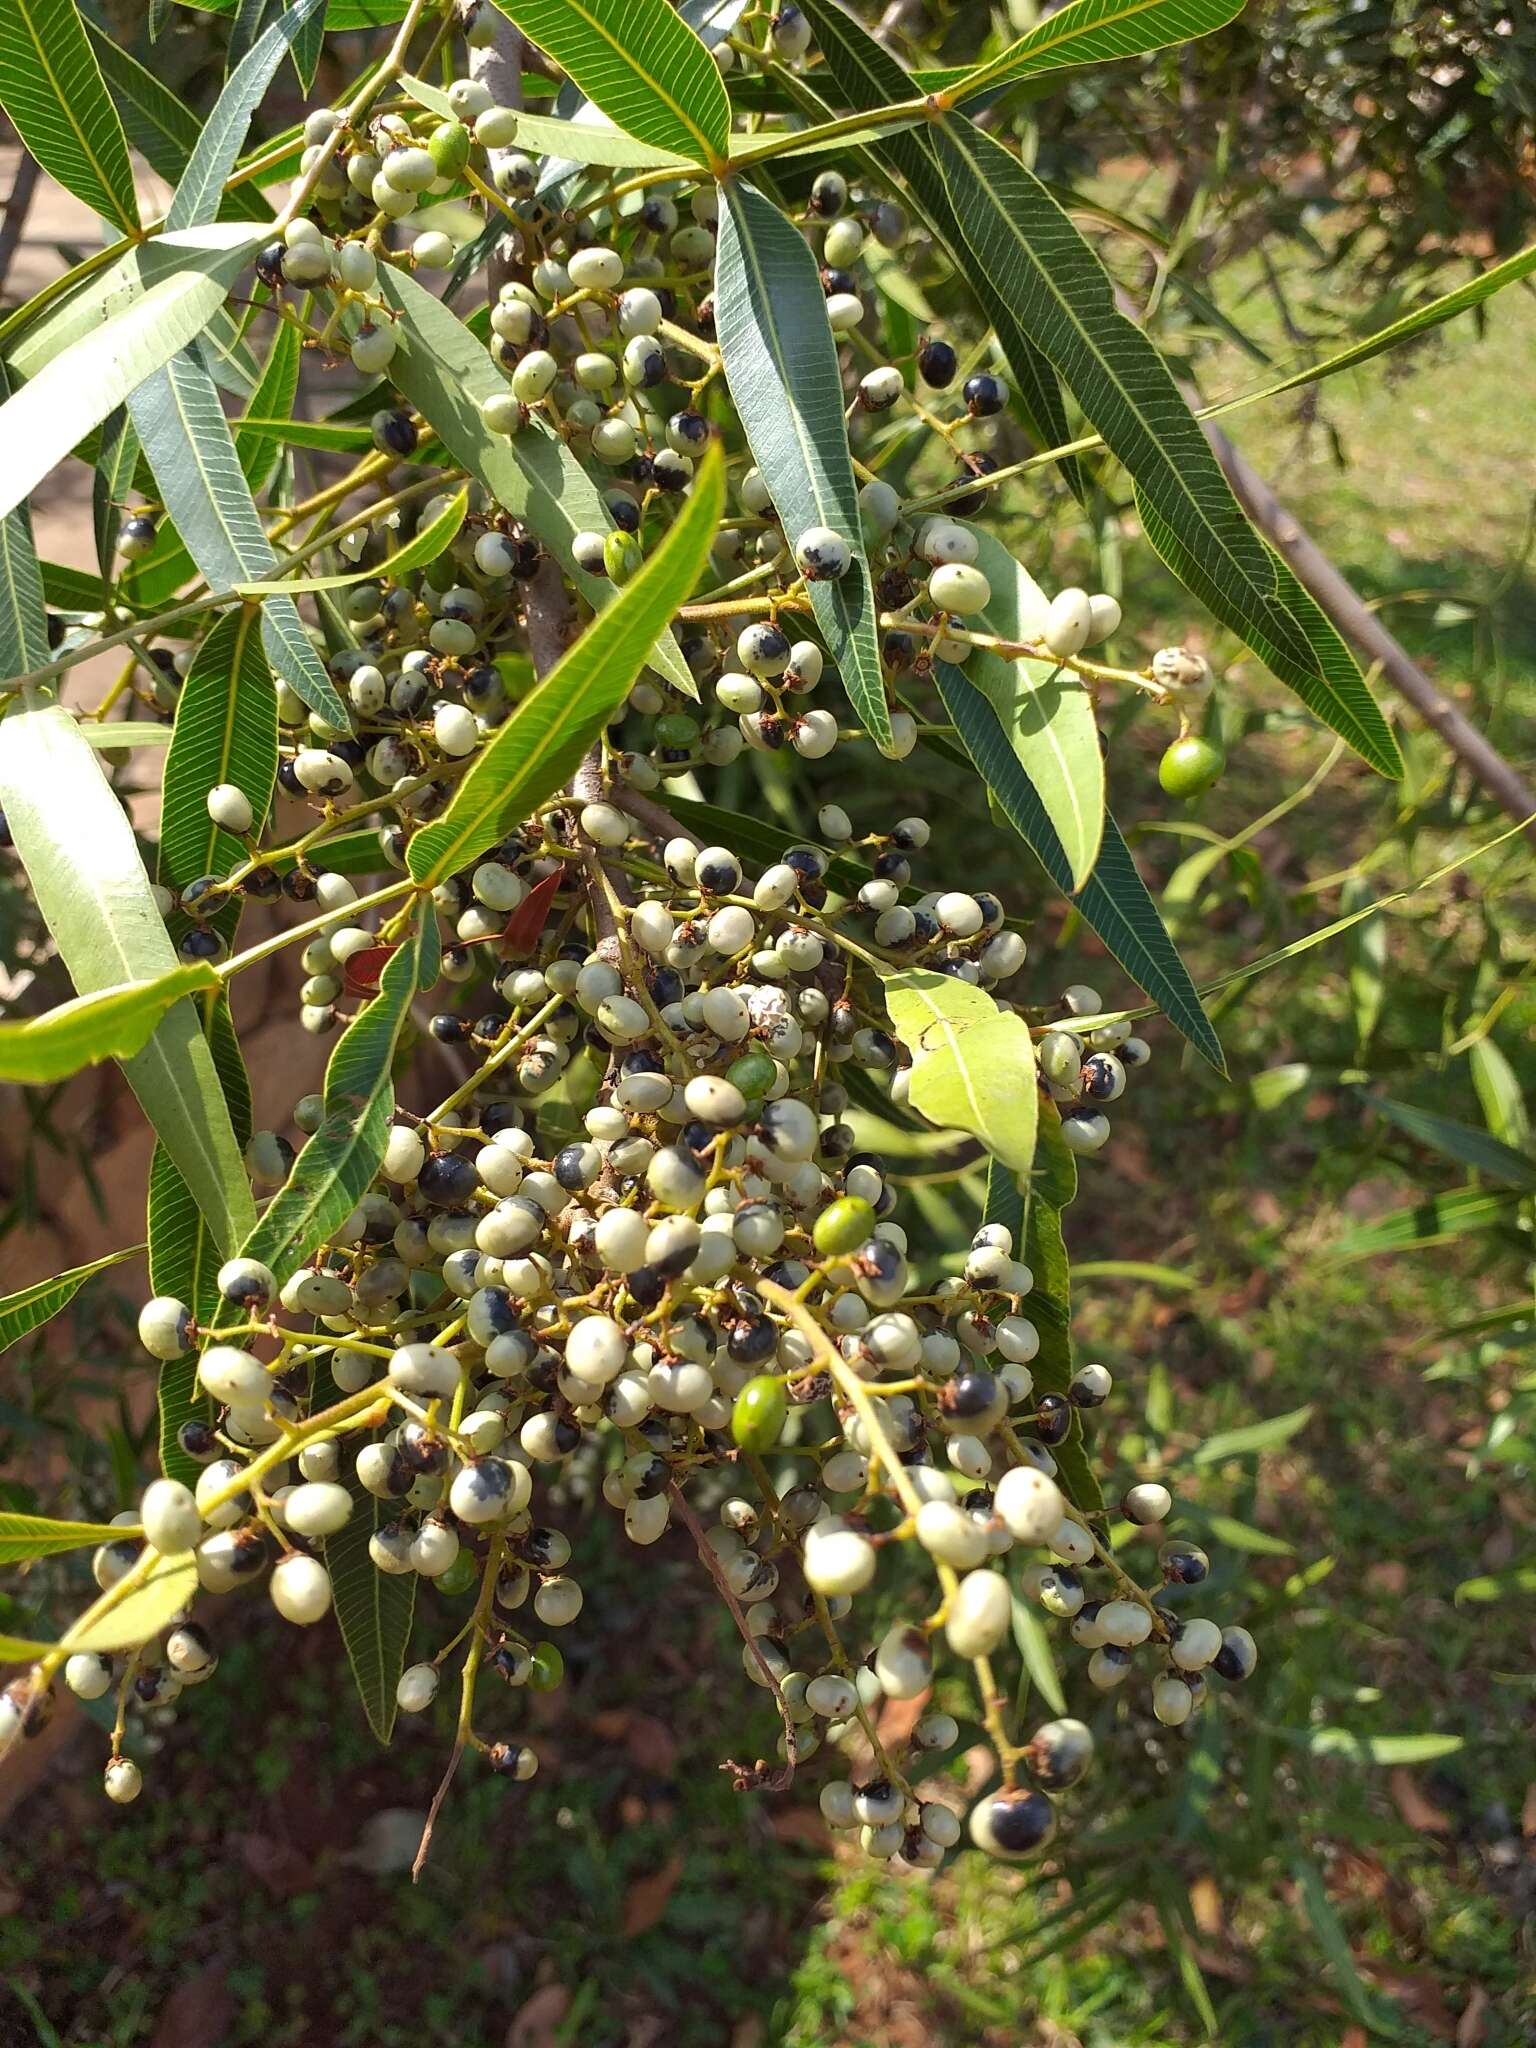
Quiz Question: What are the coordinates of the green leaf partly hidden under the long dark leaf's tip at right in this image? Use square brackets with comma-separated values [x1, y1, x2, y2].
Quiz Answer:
[1146, 487, 1403, 778]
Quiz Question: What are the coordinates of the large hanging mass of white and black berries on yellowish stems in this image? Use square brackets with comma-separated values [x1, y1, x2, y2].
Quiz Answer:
[0, 8, 1255, 1868]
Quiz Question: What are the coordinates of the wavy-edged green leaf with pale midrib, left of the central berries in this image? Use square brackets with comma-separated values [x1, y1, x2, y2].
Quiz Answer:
[240, 907, 440, 1284]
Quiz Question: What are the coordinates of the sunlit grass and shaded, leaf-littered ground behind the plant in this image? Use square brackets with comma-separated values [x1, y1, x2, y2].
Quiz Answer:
[0, 207, 1536, 2048]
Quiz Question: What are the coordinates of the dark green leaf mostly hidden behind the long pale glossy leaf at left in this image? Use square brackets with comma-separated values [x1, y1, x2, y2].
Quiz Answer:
[147, 993, 250, 1485]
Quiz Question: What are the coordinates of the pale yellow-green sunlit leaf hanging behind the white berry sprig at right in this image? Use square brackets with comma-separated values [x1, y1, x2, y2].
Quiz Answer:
[965, 526, 1104, 889]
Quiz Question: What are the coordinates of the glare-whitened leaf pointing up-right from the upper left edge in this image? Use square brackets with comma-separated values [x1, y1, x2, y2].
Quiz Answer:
[0, 223, 258, 528]
